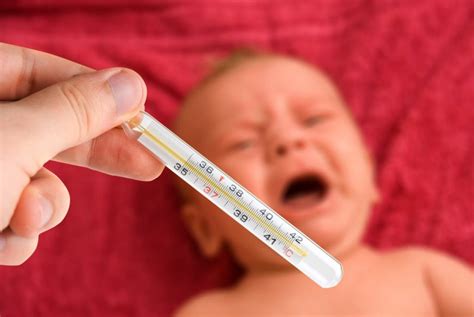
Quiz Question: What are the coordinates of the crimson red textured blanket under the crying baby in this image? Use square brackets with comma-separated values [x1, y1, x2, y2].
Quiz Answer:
[0, 0, 474, 316]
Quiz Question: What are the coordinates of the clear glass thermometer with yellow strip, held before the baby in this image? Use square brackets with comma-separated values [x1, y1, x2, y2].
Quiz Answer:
[122, 112, 343, 288]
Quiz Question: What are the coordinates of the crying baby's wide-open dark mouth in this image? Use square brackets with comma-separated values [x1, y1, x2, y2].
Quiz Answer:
[282, 174, 329, 207]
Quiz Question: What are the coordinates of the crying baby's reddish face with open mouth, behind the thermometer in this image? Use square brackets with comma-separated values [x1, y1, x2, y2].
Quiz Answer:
[177, 57, 377, 268]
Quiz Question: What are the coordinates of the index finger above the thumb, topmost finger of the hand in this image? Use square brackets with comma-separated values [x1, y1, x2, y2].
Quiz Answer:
[0, 43, 93, 101]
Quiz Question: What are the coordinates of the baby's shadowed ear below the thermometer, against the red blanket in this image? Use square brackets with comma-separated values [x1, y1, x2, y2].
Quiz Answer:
[181, 203, 224, 258]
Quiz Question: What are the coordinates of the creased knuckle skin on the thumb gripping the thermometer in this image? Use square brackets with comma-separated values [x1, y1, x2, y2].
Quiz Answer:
[58, 82, 93, 141]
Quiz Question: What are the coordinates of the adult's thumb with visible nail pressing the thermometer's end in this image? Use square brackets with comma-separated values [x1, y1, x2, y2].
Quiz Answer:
[6, 68, 146, 170]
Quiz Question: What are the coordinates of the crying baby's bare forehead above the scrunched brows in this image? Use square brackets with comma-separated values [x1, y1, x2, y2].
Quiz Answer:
[176, 57, 343, 136]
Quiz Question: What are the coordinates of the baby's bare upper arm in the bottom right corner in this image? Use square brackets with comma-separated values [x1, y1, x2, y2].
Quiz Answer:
[423, 251, 474, 316]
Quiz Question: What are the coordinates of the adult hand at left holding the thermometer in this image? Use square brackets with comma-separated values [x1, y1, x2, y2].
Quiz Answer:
[0, 43, 163, 265]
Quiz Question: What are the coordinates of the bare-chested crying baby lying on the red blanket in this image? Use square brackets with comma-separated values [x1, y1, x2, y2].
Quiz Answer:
[175, 52, 474, 317]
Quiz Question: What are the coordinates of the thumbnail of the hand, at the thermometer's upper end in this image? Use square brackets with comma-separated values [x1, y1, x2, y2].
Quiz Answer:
[109, 70, 142, 115]
